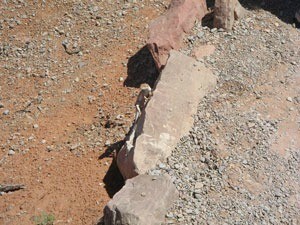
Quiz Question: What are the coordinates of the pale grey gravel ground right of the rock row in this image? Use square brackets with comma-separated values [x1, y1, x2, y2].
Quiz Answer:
[150, 1, 300, 225]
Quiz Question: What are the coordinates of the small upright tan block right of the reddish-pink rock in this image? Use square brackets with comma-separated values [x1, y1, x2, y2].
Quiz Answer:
[214, 0, 246, 30]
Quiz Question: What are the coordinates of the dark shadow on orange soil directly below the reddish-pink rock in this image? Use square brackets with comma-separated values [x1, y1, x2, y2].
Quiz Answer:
[124, 46, 159, 87]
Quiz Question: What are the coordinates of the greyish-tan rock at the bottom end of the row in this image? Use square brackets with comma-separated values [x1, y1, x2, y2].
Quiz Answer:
[104, 175, 178, 225]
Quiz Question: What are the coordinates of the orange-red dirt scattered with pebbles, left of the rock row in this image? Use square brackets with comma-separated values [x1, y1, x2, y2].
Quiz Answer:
[0, 0, 169, 225]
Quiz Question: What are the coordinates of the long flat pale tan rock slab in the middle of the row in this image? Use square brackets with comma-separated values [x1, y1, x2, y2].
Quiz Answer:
[117, 50, 216, 179]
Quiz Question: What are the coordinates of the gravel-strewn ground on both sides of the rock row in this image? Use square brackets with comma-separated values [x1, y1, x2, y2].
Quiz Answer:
[0, 0, 300, 225]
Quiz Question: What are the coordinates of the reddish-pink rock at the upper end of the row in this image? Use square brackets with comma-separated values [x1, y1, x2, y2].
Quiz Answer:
[147, 0, 207, 69]
